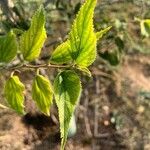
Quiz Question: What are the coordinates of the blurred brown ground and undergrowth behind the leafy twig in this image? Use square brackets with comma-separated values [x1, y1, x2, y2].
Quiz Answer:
[0, 0, 150, 150]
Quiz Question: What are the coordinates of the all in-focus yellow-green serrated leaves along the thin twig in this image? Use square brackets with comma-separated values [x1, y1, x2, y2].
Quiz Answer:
[0, 0, 111, 150]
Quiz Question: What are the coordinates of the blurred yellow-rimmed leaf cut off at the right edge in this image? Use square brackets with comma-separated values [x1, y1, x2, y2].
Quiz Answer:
[140, 19, 150, 37]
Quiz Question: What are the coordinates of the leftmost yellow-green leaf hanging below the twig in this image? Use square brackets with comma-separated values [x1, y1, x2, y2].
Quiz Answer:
[4, 76, 25, 114]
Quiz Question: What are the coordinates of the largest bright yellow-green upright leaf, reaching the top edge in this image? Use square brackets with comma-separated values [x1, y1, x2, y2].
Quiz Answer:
[69, 0, 97, 67]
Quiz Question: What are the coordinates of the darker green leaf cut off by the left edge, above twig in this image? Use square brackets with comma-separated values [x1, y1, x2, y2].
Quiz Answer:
[0, 32, 17, 63]
